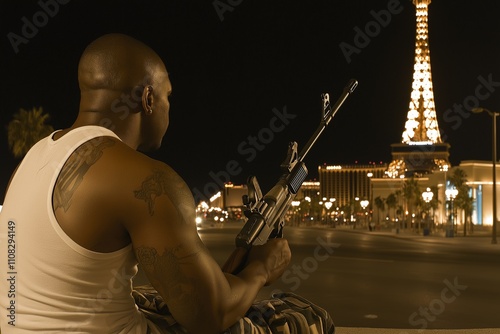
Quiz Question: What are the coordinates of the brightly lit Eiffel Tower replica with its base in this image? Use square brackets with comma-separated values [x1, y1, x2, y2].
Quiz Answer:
[386, 0, 450, 178]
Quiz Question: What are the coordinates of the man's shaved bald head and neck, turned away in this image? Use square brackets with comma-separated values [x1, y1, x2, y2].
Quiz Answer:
[72, 34, 172, 149]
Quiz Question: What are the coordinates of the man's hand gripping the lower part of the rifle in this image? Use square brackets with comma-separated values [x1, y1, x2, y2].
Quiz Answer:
[247, 238, 292, 285]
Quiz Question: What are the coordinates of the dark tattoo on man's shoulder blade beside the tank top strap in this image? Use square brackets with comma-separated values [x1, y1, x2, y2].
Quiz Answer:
[53, 137, 115, 212]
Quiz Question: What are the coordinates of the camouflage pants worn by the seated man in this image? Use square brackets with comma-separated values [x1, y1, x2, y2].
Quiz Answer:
[132, 285, 335, 334]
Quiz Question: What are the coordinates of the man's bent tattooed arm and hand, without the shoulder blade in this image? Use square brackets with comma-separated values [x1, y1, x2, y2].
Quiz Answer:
[125, 161, 290, 333]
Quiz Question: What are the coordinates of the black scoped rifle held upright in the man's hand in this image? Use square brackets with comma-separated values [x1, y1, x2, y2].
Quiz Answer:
[222, 79, 358, 274]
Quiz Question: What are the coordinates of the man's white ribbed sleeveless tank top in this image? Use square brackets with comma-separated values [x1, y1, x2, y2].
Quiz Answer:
[0, 126, 147, 334]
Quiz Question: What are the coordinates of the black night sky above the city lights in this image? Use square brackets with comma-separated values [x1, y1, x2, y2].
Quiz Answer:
[0, 0, 500, 198]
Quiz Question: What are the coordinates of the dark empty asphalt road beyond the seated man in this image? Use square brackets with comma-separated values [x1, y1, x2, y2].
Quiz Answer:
[195, 223, 500, 333]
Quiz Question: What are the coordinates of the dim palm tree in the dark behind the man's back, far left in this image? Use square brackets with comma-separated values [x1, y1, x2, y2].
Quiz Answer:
[7, 107, 54, 158]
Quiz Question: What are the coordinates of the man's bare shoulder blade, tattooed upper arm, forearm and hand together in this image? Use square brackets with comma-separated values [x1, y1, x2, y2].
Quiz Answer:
[53, 137, 290, 334]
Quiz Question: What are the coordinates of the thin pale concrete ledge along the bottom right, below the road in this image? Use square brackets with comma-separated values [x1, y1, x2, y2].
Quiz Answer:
[335, 327, 500, 334]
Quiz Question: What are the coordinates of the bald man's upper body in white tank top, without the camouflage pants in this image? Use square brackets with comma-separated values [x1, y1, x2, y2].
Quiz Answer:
[0, 34, 333, 334]
